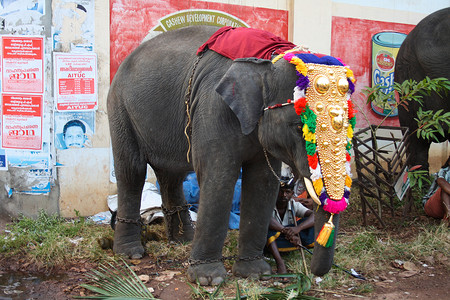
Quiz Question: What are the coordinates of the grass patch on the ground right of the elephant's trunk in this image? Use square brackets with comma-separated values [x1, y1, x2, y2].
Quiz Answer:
[319, 219, 450, 294]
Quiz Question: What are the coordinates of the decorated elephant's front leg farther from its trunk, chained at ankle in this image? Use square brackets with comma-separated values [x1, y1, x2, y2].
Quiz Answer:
[187, 165, 240, 285]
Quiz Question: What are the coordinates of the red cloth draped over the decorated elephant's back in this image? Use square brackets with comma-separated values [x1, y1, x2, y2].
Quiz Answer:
[197, 26, 295, 60]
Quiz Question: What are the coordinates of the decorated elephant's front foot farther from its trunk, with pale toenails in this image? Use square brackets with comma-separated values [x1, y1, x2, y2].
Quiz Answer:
[187, 262, 227, 285]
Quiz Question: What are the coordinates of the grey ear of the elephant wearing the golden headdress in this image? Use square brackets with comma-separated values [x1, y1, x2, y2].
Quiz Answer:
[216, 58, 272, 135]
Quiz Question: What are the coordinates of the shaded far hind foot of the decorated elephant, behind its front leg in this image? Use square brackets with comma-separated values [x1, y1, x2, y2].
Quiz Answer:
[163, 206, 194, 243]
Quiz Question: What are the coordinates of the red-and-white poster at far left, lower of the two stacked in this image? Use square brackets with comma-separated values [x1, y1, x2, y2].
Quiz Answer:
[2, 94, 43, 150]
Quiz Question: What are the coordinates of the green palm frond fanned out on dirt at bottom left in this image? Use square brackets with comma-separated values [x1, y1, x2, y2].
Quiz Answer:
[76, 260, 156, 300]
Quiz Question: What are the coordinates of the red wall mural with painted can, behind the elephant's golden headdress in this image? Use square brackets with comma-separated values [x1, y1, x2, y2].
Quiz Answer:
[331, 17, 415, 128]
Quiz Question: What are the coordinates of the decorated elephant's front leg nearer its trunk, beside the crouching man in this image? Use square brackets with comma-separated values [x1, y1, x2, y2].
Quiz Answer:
[233, 161, 280, 278]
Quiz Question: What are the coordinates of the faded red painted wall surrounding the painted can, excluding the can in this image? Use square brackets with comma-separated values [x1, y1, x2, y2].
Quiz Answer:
[331, 17, 415, 128]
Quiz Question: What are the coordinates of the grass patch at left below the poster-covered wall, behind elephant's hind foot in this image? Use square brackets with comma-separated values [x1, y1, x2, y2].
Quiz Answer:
[0, 211, 112, 268]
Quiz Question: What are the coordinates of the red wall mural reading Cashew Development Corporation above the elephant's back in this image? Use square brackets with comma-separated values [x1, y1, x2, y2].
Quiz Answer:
[110, 0, 288, 80]
